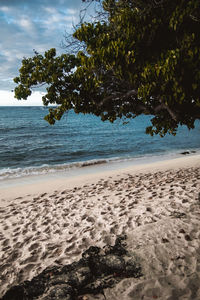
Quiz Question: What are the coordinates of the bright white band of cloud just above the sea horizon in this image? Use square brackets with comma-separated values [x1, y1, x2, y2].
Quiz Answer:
[0, 90, 44, 106]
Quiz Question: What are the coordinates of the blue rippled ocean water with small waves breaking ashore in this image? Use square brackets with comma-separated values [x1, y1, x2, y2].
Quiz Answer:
[0, 107, 200, 180]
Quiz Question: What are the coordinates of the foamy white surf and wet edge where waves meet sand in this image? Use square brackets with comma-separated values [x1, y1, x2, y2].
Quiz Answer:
[0, 148, 200, 180]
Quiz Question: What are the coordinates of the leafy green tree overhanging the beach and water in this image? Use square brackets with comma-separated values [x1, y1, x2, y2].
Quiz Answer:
[14, 0, 200, 136]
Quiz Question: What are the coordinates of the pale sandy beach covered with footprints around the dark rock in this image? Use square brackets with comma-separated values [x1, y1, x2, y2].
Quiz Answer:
[0, 155, 200, 300]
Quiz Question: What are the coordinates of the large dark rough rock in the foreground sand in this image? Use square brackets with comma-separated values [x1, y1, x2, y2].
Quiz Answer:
[1, 236, 142, 300]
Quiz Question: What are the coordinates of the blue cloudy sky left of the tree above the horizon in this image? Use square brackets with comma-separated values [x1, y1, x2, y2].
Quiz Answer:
[0, 0, 96, 106]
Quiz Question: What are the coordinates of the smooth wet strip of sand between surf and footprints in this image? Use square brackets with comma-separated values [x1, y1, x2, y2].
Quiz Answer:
[0, 153, 200, 206]
